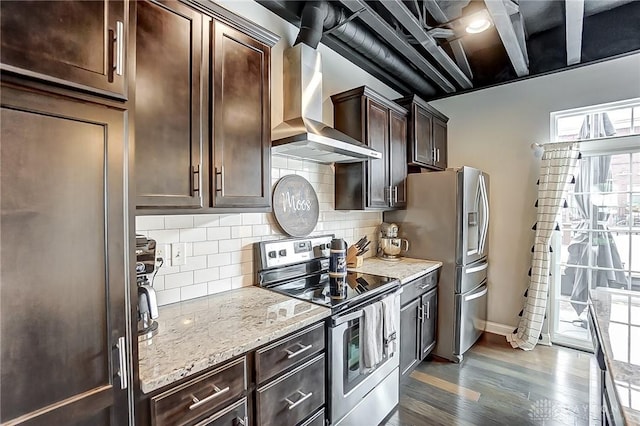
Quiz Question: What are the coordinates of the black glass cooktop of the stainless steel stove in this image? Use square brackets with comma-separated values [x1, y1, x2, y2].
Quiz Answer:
[269, 272, 400, 310]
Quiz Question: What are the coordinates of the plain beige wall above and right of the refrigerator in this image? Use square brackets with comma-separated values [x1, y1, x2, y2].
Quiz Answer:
[430, 54, 640, 327]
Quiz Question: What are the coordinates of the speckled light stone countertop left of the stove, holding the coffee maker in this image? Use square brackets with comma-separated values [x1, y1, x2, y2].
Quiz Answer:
[138, 287, 331, 393]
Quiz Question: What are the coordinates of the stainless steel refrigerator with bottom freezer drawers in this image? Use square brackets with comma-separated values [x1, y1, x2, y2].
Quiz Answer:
[384, 166, 489, 362]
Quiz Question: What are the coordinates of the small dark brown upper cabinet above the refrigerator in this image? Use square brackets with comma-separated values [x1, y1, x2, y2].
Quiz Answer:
[396, 95, 449, 170]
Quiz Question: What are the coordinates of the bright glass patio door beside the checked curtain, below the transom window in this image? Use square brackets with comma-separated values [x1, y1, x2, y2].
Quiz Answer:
[550, 148, 640, 348]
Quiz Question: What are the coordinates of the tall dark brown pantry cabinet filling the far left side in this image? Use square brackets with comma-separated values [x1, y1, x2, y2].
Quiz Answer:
[0, 0, 135, 426]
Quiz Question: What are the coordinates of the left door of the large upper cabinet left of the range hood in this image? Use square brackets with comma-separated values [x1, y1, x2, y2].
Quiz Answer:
[135, 1, 206, 208]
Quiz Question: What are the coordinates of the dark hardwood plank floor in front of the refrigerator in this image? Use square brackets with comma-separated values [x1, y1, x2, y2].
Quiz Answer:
[383, 333, 599, 426]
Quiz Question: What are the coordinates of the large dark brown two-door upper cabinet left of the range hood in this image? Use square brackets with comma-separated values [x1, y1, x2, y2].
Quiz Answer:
[135, 0, 276, 214]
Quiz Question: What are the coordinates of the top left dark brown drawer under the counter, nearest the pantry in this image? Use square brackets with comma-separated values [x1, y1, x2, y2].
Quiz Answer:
[151, 357, 247, 426]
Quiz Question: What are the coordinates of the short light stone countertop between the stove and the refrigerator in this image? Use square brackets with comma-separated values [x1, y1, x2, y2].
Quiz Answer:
[349, 257, 442, 284]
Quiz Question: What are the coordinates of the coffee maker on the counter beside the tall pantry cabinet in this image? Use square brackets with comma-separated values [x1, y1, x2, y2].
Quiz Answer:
[136, 235, 158, 340]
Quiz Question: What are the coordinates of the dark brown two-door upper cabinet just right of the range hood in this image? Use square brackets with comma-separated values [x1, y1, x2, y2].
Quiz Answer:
[331, 86, 407, 210]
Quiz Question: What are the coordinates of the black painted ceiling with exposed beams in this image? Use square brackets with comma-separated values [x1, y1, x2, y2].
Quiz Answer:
[258, 0, 640, 100]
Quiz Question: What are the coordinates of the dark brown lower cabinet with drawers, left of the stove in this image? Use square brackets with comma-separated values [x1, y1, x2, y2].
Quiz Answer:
[143, 322, 326, 426]
